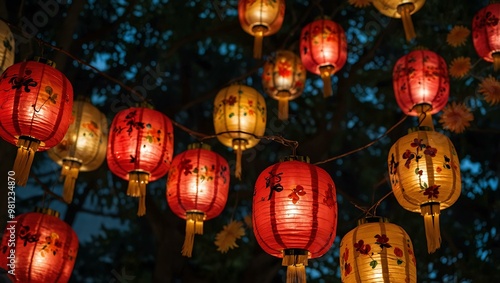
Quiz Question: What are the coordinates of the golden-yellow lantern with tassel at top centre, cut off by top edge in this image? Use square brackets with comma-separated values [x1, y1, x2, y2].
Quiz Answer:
[238, 0, 285, 59]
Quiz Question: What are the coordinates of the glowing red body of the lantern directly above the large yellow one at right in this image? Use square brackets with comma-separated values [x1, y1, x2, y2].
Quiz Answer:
[392, 50, 450, 116]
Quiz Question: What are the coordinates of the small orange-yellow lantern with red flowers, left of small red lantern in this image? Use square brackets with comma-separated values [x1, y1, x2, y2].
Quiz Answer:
[262, 50, 306, 120]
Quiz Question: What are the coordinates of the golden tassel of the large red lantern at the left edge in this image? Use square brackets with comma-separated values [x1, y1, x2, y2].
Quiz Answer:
[12, 136, 40, 186]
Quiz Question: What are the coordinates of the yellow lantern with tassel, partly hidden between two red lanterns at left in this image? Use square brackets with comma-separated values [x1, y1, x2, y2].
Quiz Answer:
[47, 100, 108, 203]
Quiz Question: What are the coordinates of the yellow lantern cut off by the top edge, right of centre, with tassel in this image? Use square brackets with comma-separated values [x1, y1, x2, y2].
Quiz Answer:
[372, 0, 425, 41]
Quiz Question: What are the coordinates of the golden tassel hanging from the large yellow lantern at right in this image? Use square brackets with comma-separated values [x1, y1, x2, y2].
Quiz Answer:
[420, 203, 441, 253]
